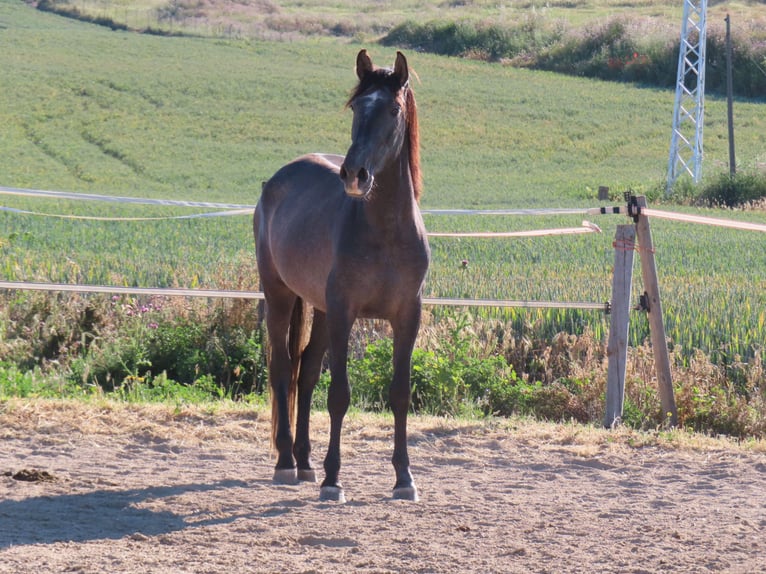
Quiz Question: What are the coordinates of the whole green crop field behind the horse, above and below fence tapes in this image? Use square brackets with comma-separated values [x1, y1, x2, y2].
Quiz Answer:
[0, 0, 766, 364]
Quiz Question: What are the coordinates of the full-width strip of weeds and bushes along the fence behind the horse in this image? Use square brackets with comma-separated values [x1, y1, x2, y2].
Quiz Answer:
[0, 293, 766, 438]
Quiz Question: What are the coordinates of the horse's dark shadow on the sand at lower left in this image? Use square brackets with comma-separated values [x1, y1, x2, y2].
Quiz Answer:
[0, 480, 258, 550]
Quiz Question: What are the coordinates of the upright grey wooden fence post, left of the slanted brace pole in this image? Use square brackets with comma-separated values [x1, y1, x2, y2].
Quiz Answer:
[604, 225, 636, 428]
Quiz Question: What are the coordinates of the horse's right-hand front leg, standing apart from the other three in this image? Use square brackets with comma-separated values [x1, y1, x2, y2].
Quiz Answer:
[389, 302, 420, 501]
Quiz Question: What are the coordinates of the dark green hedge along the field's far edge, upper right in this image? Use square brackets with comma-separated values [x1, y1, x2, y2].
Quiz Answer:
[382, 16, 766, 98]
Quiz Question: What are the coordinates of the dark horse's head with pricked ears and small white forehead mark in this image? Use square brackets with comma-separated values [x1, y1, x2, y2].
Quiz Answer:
[340, 50, 415, 198]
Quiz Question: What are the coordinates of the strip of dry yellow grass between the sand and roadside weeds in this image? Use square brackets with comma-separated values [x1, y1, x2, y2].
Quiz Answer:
[0, 399, 766, 458]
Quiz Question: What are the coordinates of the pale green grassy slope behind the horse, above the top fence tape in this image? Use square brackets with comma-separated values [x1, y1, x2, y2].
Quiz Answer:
[6, 2, 766, 207]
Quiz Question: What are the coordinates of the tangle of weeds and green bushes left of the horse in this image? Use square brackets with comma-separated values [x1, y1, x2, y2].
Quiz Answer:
[0, 292, 267, 396]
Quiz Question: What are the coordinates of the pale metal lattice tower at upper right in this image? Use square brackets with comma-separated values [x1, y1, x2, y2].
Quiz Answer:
[666, 0, 707, 193]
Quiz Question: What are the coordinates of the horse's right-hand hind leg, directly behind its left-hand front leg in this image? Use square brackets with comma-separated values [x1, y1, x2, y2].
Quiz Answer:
[293, 309, 328, 482]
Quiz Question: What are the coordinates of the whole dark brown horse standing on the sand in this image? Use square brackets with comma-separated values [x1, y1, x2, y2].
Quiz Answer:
[253, 50, 431, 502]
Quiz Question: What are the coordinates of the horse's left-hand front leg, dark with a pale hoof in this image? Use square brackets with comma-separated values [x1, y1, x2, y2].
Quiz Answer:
[319, 302, 354, 502]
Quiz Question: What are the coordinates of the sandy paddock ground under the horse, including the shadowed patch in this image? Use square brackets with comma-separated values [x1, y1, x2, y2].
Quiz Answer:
[0, 401, 766, 574]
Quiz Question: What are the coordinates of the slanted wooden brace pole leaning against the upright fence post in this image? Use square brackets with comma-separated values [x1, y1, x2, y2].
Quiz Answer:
[636, 196, 678, 426]
